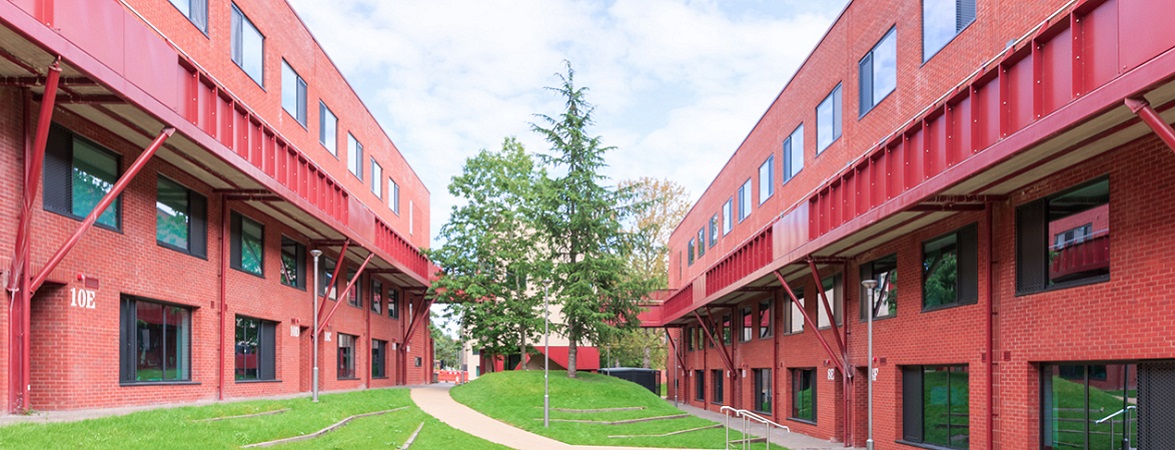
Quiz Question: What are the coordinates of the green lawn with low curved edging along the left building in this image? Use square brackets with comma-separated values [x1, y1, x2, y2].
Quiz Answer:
[0, 389, 502, 450]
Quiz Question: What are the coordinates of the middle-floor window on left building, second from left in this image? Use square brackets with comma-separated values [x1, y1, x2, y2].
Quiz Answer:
[155, 176, 208, 257]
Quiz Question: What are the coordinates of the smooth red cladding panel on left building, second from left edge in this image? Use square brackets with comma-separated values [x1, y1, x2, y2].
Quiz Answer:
[52, 0, 124, 74]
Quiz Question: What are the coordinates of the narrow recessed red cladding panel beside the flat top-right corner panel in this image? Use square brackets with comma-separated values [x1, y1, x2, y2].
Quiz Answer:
[1077, 0, 1118, 93]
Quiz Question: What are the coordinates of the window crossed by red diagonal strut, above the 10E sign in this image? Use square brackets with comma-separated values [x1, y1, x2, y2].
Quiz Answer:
[42, 125, 122, 230]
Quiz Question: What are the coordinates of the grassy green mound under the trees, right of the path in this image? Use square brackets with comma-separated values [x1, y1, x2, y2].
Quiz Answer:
[452, 370, 781, 449]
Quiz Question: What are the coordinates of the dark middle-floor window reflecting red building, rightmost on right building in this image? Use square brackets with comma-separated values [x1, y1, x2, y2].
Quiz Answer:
[1016, 177, 1110, 295]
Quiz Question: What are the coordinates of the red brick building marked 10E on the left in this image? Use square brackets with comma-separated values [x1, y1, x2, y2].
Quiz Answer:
[0, 0, 432, 411]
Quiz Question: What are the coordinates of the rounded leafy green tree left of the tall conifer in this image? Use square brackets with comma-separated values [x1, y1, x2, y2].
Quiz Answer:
[429, 139, 549, 373]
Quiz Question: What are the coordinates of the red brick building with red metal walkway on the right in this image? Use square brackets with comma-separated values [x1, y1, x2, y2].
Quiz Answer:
[643, 0, 1175, 449]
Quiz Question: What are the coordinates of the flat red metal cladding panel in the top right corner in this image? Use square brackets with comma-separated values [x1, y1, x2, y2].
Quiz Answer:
[1117, 0, 1175, 72]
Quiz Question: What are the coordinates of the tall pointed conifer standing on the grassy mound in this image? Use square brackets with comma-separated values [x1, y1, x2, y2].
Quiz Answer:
[531, 62, 652, 378]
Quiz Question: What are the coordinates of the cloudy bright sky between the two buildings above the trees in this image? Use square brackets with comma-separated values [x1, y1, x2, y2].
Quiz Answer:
[290, 0, 844, 246]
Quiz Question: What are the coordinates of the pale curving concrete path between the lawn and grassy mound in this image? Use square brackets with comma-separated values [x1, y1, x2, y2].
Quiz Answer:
[412, 384, 695, 450]
